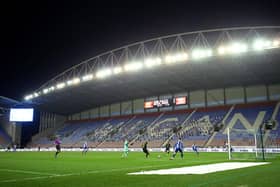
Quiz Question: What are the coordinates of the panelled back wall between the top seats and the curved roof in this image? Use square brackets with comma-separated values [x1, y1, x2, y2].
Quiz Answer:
[68, 84, 280, 120]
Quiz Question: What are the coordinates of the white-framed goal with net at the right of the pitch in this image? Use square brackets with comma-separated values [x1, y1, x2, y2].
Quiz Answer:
[227, 128, 273, 160]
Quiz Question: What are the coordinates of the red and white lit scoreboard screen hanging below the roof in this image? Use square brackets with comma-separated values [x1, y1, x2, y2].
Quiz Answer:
[144, 96, 187, 109]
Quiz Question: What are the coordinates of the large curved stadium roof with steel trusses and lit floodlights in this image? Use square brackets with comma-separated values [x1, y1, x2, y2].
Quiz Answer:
[23, 27, 280, 114]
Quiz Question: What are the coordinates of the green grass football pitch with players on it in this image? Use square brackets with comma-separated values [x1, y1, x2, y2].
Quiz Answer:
[0, 152, 280, 187]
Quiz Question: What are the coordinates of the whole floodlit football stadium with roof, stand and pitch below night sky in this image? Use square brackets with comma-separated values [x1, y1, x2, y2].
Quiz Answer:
[0, 26, 280, 187]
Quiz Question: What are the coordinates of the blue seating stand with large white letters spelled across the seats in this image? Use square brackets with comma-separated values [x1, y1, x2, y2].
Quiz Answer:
[29, 102, 280, 148]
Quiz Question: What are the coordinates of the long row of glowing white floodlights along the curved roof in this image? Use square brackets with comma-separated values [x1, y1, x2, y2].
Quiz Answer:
[24, 38, 280, 100]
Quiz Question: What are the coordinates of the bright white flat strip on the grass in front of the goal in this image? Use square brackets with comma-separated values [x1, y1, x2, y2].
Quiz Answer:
[128, 162, 270, 175]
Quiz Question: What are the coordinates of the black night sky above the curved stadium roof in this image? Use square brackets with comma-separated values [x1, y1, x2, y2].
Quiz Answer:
[0, 0, 280, 100]
